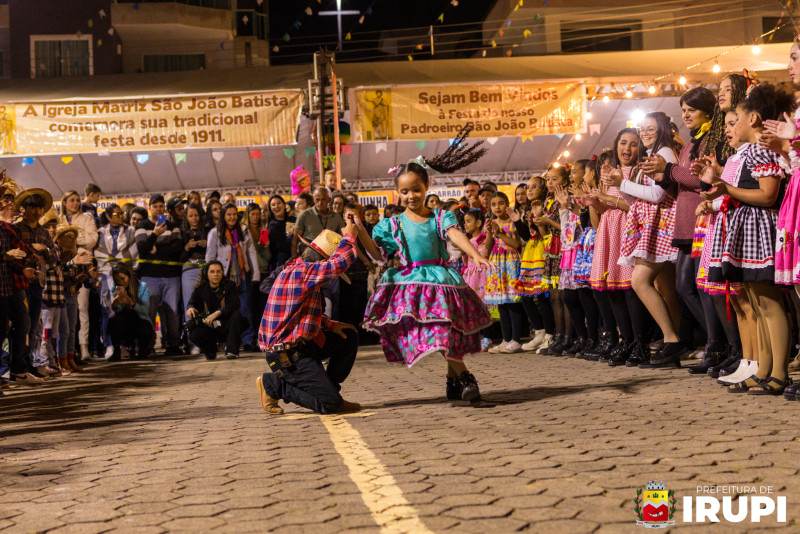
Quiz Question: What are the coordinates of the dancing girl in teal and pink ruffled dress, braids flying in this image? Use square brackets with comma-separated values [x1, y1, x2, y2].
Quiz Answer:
[359, 128, 492, 402]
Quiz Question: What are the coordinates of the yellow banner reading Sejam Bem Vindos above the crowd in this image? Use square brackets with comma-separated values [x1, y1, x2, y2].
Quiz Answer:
[351, 82, 586, 142]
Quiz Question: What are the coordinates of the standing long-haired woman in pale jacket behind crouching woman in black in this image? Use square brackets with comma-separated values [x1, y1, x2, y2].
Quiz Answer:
[206, 203, 261, 351]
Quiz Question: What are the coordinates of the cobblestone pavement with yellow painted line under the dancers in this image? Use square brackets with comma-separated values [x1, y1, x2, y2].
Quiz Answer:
[0, 348, 800, 534]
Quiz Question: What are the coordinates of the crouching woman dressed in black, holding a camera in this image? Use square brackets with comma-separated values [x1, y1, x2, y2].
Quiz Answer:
[185, 260, 247, 360]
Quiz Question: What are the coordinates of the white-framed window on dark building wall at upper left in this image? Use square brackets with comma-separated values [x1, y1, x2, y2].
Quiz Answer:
[31, 35, 94, 78]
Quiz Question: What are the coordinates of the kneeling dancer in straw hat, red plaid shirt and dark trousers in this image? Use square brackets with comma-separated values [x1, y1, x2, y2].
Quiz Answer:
[256, 215, 361, 415]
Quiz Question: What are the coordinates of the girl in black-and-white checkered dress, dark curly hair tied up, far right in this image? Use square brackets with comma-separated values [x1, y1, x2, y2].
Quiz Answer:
[704, 84, 794, 395]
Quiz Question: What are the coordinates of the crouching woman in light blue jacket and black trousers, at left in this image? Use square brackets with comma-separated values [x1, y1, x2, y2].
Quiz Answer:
[108, 262, 156, 361]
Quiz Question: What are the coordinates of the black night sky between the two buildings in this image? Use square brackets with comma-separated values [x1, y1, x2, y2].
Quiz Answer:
[269, 0, 496, 65]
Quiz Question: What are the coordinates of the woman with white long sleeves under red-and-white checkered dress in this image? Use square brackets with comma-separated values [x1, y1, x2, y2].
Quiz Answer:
[603, 112, 686, 367]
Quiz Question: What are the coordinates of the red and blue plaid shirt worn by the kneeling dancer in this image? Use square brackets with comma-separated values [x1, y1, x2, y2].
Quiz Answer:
[258, 234, 356, 350]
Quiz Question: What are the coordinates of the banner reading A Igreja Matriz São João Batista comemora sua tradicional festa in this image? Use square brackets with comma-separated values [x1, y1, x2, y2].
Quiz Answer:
[0, 90, 303, 155]
